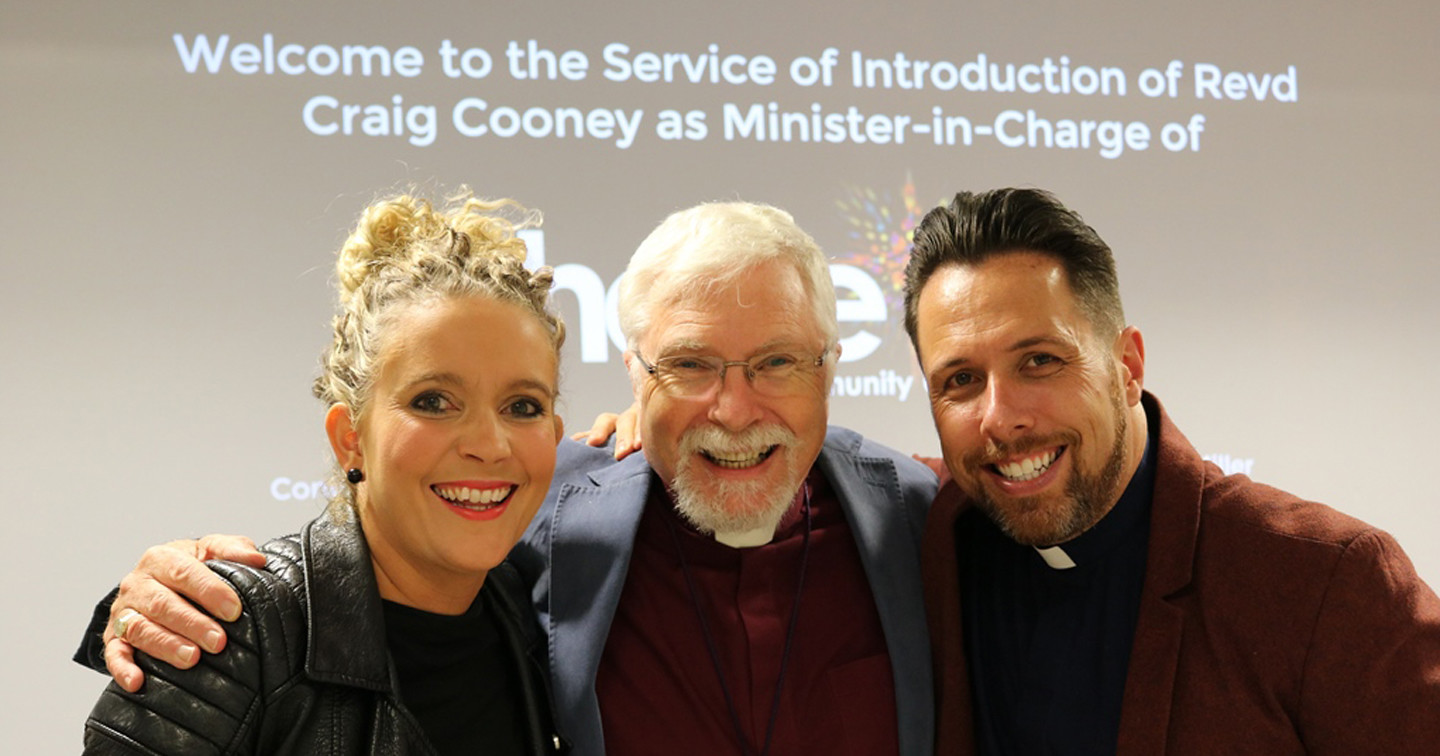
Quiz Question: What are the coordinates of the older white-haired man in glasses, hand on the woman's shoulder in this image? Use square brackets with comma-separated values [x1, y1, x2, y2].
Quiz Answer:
[78, 203, 936, 756]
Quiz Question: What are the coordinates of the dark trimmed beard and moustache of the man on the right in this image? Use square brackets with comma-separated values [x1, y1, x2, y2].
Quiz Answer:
[965, 380, 1130, 546]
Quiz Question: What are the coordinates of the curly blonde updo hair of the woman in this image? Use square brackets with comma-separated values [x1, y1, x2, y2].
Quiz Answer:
[314, 190, 564, 507]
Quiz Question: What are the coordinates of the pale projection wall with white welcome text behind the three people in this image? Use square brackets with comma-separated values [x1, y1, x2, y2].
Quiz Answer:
[0, 0, 1440, 753]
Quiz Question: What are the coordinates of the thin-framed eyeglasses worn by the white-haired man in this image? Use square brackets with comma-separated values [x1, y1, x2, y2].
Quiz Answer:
[635, 350, 828, 399]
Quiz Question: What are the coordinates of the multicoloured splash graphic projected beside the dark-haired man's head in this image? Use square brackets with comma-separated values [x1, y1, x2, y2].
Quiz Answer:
[835, 173, 929, 312]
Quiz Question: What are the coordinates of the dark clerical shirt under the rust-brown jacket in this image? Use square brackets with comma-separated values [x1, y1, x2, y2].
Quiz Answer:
[955, 417, 1155, 756]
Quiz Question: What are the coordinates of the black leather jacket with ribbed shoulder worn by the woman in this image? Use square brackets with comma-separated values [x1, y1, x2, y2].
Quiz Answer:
[75, 504, 567, 756]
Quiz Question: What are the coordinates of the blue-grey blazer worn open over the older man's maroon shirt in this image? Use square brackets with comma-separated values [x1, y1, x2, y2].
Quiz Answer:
[510, 426, 936, 756]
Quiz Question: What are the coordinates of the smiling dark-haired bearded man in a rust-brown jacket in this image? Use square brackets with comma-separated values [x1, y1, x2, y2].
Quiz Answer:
[906, 189, 1440, 755]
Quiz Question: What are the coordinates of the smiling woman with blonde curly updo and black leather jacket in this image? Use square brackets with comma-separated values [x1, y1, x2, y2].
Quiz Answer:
[85, 194, 564, 755]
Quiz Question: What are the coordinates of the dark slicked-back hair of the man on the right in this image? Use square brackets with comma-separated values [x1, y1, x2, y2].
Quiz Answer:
[904, 189, 1125, 347]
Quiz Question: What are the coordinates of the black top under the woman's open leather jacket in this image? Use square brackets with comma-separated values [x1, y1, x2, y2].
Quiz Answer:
[383, 583, 524, 755]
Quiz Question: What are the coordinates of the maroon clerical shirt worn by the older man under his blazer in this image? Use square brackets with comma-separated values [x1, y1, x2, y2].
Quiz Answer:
[595, 471, 899, 756]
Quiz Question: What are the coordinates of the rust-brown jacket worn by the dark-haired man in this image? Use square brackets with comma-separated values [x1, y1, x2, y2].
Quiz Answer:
[922, 395, 1440, 756]
